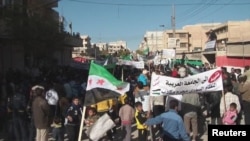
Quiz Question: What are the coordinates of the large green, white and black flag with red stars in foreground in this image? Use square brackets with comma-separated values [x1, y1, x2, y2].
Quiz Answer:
[84, 62, 130, 106]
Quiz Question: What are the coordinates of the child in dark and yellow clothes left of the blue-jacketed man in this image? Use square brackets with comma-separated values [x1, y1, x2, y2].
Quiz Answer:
[135, 102, 148, 141]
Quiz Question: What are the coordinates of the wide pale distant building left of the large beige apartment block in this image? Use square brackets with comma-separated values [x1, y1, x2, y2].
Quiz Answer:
[108, 41, 128, 54]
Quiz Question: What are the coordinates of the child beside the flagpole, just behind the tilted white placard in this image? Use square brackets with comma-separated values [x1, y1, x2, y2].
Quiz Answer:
[84, 107, 99, 136]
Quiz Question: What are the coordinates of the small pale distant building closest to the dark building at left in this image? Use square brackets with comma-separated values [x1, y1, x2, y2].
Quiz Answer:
[72, 35, 91, 58]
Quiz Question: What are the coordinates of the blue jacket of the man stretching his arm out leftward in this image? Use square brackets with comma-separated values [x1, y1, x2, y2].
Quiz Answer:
[145, 109, 190, 141]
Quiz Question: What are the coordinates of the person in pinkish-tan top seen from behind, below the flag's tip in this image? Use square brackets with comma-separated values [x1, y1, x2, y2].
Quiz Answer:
[119, 98, 135, 141]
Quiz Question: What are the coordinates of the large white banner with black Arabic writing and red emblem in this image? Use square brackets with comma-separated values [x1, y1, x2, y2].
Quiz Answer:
[150, 68, 223, 96]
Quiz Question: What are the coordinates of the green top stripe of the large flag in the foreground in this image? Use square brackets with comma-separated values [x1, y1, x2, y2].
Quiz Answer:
[89, 62, 124, 86]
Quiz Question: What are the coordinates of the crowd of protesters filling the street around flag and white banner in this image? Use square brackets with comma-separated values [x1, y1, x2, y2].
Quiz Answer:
[0, 64, 250, 141]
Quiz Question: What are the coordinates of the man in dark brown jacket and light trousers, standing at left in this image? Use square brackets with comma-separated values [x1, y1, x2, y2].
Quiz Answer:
[32, 88, 50, 141]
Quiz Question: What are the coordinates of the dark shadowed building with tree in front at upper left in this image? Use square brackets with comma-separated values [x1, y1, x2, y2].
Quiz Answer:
[0, 0, 81, 72]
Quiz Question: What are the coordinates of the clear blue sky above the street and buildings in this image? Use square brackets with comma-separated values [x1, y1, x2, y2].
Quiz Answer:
[56, 0, 250, 51]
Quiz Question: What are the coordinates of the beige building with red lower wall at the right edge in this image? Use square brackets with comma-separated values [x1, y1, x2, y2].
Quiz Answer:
[202, 20, 250, 67]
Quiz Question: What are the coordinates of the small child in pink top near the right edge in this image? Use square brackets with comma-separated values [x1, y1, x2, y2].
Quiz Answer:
[222, 102, 238, 125]
